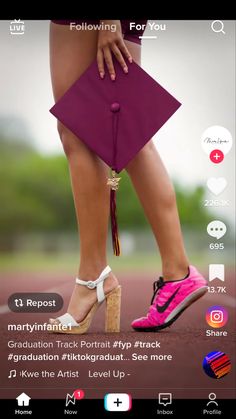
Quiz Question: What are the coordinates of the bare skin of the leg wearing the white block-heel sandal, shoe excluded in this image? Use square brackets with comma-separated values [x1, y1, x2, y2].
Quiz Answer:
[50, 23, 117, 322]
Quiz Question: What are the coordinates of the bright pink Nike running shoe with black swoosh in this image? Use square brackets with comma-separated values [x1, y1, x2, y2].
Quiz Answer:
[131, 266, 207, 332]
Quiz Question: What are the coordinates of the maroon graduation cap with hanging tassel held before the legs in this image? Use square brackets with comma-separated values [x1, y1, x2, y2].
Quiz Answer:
[50, 59, 181, 256]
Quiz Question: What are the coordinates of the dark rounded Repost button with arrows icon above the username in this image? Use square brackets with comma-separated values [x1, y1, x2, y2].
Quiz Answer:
[8, 292, 63, 313]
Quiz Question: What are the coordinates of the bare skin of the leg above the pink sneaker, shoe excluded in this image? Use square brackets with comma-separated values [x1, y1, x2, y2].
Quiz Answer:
[127, 42, 189, 280]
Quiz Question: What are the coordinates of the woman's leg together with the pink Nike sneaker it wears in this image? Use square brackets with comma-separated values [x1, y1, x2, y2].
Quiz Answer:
[127, 41, 207, 332]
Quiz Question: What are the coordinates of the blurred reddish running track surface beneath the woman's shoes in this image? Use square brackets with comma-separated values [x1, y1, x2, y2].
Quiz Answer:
[0, 273, 235, 399]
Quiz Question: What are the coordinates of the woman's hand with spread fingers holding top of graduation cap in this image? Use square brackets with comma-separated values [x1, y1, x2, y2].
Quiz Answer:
[97, 20, 132, 80]
